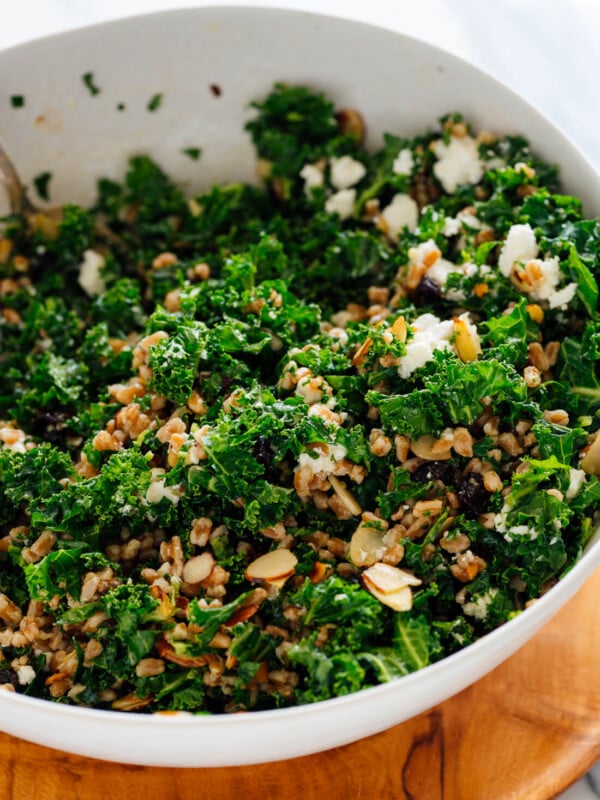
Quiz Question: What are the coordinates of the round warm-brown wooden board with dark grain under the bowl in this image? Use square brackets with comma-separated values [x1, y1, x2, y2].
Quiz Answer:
[0, 571, 600, 800]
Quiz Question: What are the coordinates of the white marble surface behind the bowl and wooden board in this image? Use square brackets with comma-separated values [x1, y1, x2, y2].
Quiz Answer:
[0, 0, 600, 800]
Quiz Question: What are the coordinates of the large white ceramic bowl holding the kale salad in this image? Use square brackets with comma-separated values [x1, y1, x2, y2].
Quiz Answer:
[0, 7, 600, 767]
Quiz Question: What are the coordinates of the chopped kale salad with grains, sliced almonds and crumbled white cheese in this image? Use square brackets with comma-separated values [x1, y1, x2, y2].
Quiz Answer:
[0, 84, 600, 713]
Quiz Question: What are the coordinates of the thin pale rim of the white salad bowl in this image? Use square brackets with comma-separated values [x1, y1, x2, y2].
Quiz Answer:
[0, 0, 600, 740]
